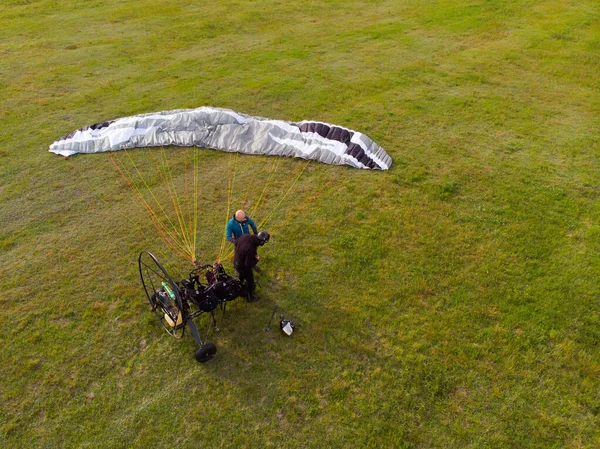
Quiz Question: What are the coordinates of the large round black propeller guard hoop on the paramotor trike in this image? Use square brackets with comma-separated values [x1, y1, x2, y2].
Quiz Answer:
[138, 251, 186, 338]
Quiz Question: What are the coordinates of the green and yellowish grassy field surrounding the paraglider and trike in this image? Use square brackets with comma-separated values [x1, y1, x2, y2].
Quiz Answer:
[0, 0, 600, 448]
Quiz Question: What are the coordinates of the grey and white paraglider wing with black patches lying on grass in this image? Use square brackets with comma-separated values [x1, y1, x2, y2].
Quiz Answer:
[50, 107, 392, 170]
